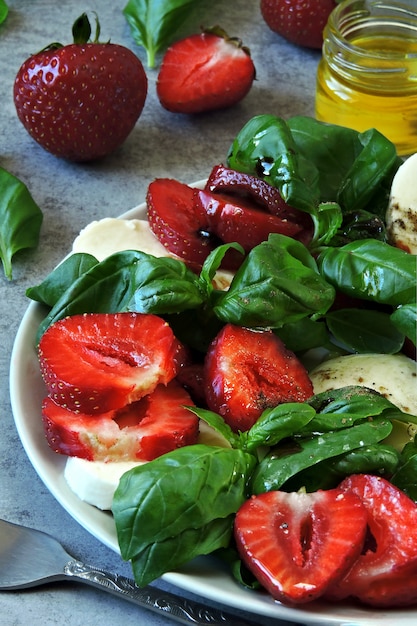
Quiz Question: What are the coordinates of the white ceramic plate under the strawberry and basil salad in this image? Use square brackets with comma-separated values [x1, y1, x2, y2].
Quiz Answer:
[10, 196, 417, 626]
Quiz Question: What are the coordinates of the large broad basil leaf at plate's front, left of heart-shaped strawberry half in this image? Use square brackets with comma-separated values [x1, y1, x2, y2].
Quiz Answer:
[112, 444, 256, 585]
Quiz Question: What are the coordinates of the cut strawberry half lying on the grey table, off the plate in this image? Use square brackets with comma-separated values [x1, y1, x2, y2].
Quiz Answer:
[157, 27, 255, 113]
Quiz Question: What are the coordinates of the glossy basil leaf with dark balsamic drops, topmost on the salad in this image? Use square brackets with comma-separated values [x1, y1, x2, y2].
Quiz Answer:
[227, 115, 320, 213]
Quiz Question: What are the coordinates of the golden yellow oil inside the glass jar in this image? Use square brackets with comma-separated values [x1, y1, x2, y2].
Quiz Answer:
[316, 34, 417, 155]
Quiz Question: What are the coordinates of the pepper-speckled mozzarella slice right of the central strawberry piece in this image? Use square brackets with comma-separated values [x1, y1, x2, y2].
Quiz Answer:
[309, 354, 417, 449]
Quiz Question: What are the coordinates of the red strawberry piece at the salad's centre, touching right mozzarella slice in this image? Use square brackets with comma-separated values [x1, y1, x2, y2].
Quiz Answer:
[205, 324, 313, 432]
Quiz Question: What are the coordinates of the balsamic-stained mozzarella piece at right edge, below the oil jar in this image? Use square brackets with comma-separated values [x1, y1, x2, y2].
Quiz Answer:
[386, 153, 417, 254]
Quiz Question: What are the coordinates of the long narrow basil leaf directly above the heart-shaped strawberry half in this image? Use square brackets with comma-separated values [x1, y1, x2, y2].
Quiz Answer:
[252, 417, 392, 494]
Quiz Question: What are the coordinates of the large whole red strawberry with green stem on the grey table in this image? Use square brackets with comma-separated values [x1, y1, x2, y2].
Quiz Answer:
[14, 14, 147, 161]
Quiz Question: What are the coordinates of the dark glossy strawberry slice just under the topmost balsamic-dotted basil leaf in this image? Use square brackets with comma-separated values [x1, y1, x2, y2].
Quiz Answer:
[205, 164, 314, 244]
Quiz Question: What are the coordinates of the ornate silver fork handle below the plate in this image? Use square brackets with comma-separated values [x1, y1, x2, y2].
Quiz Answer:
[64, 560, 256, 626]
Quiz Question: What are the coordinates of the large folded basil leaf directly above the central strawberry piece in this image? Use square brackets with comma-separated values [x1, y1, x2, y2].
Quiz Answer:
[214, 234, 335, 328]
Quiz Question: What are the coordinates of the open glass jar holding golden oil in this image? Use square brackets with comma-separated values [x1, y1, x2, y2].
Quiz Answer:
[316, 0, 417, 155]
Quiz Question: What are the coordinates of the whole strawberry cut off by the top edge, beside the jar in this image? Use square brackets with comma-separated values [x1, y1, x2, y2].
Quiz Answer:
[261, 0, 336, 48]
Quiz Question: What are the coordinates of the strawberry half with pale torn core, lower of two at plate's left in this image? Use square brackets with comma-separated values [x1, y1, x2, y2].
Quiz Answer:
[42, 381, 198, 461]
